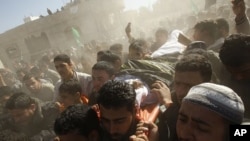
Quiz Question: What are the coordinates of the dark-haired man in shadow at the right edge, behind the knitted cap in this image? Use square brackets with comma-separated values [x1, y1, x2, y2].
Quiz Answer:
[219, 34, 250, 118]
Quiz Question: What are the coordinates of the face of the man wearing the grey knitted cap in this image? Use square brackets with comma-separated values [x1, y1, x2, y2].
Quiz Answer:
[176, 101, 229, 141]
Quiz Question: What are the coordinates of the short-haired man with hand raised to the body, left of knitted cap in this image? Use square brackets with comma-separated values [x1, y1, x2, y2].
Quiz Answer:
[151, 54, 212, 141]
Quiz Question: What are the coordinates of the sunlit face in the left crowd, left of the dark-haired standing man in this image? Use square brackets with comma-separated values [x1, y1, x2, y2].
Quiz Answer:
[24, 77, 41, 93]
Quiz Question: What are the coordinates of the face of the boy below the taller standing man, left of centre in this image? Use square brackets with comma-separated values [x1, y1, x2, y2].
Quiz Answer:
[59, 92, 81, 108]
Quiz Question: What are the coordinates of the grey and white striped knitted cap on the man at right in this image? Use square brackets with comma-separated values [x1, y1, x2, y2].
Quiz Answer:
[183, 83, 245, 124]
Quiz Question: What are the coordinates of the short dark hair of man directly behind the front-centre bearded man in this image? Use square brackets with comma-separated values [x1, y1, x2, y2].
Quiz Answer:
[92, 61, 115, 77]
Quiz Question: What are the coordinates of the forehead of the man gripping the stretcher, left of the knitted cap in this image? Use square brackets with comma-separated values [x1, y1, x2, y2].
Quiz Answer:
[174, 71, 203, 85]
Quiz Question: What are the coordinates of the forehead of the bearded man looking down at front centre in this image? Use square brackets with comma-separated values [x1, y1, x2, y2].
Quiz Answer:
[100, 105, 132, 120]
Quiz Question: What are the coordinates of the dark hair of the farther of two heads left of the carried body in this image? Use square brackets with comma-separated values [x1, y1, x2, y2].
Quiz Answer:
[98, 51, 121, 64]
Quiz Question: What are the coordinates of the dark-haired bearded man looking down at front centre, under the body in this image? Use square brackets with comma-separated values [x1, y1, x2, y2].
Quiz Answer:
[97, 81, 139, 141]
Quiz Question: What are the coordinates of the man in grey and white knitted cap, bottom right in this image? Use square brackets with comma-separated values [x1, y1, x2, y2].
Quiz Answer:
[176, 83, 244, 141]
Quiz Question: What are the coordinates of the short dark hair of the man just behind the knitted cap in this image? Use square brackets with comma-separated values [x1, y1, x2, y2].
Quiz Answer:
[175, 54, 212, 82]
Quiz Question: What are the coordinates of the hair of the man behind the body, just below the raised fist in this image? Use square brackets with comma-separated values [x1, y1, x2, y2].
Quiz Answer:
[129, 39, 148, 53]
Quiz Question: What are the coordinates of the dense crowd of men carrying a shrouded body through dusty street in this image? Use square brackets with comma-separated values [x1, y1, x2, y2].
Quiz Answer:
[0, 1, 250, 141]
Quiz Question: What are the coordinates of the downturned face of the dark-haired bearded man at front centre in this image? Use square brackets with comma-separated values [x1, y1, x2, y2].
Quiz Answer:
[100, 105, 135, 140]
